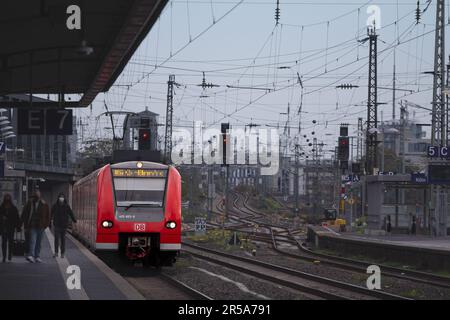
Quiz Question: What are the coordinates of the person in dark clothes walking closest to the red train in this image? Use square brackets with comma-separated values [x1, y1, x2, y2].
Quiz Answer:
[51, 193, 77, 258]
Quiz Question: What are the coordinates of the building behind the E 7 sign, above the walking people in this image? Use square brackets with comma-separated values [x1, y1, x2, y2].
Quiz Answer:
[0, 94, 77, 207]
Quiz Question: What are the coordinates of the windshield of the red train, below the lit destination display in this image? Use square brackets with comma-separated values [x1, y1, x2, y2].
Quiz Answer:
[114, 177, 166, 208]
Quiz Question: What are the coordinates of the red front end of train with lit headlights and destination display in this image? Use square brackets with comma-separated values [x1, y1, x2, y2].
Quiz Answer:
[108, 161, 181, 265]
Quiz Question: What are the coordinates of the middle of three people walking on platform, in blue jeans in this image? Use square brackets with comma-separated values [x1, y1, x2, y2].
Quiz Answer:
[22, 191, 50, 262]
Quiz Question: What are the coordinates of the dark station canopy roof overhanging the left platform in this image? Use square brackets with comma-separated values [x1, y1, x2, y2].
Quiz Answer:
[0, 0, 167, 107]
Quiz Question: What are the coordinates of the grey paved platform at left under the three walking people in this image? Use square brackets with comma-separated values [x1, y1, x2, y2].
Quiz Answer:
[0, 229, 144, 300]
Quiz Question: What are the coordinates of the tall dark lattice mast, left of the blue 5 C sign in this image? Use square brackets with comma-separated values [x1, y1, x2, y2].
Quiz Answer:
[366, 27, 378, 175]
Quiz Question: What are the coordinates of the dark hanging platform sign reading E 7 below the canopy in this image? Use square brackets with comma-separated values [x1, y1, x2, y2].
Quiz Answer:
[17, 109, 73, 136]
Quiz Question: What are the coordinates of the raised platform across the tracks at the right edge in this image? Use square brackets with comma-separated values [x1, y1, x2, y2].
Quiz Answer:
[308, 226, 450, 271]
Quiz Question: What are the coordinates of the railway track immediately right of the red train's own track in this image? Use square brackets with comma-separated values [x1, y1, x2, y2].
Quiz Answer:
[183, 242, 409, 300]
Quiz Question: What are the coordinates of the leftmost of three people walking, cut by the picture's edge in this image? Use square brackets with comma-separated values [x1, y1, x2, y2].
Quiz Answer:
[0, 193, 20, 262]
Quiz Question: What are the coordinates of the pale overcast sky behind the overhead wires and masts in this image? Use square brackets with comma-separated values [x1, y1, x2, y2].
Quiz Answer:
[76, 0, 450, 158]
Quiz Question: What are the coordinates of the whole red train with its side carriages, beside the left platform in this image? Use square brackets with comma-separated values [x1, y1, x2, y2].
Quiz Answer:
[73, 161, 181, 266]
